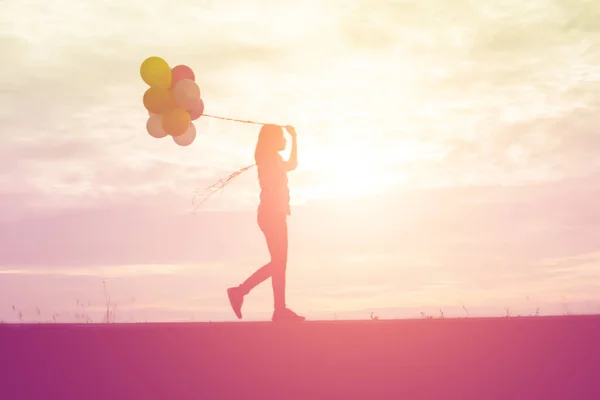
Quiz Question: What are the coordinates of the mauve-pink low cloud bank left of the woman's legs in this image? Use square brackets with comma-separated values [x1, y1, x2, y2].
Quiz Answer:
[0, 206, 260, 268]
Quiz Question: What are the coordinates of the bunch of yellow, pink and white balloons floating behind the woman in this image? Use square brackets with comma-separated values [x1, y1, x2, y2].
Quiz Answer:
[140, 57, 204, 146]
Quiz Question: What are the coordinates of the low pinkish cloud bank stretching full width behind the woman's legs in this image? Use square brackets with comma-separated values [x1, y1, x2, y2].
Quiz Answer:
[0, 176, 600, 284]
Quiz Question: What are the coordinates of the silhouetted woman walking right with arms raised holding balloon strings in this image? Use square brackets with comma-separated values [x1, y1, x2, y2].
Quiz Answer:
[227, 125, 304, 322]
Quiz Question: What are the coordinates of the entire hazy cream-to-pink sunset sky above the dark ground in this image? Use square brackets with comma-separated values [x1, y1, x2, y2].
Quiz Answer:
[0, 0, 600, 322]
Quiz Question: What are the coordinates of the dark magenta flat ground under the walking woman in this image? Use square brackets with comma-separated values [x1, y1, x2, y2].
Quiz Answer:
[0, 316, 600, 400]
